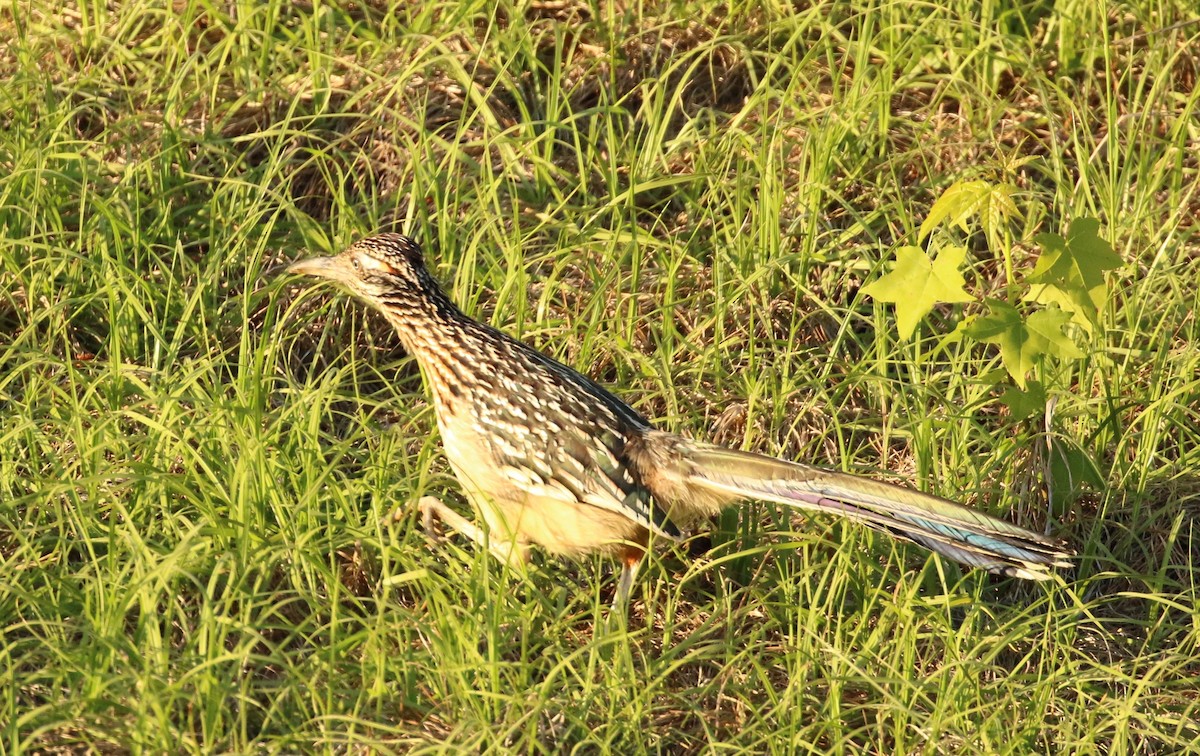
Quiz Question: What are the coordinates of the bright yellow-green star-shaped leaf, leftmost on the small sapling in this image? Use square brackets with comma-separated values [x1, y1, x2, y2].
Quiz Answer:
[863, 247, 974, 341]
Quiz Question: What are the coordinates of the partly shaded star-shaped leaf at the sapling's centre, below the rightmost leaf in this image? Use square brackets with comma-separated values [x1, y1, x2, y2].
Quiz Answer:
[967, 299, 1084, 389]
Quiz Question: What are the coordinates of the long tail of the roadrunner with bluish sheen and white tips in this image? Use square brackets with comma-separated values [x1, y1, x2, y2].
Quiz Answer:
[679, 442, 1072, 580]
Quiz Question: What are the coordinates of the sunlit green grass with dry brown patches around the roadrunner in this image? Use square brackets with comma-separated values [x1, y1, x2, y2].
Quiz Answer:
[0, 0, 1200, 754]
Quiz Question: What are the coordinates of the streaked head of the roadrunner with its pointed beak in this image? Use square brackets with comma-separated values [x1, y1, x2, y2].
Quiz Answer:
[287, 234, 440, 306]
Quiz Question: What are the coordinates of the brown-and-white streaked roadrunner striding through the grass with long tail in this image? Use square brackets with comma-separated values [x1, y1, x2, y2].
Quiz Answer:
[288, 234, 1072, 604]
